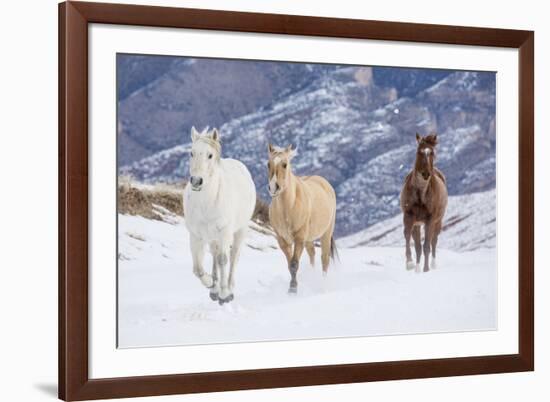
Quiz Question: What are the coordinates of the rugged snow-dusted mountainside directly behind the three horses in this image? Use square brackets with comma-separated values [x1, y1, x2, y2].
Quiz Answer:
[119, 66, 496, 236]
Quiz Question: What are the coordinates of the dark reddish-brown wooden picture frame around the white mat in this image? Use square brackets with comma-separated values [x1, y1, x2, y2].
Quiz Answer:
[59, 2, 534, 400]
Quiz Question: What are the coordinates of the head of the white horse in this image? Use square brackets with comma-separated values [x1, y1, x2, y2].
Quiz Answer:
[189, 127, 221, 191]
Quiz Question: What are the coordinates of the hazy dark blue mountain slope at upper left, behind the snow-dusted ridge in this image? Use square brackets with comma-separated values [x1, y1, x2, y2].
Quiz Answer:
[117, 55, 332, 165]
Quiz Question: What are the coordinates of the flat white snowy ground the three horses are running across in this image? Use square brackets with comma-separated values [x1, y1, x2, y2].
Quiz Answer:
[118, 204, 497, 348]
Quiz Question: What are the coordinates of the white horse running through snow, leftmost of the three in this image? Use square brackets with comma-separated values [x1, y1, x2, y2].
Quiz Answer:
[183, 127, 256, 305]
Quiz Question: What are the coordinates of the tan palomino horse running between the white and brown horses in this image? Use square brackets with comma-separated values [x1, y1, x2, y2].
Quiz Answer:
[267, 144, 336, 293]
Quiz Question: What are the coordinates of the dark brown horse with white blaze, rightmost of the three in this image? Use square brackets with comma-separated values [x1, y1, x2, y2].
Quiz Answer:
[401, 133, 447, 272]
